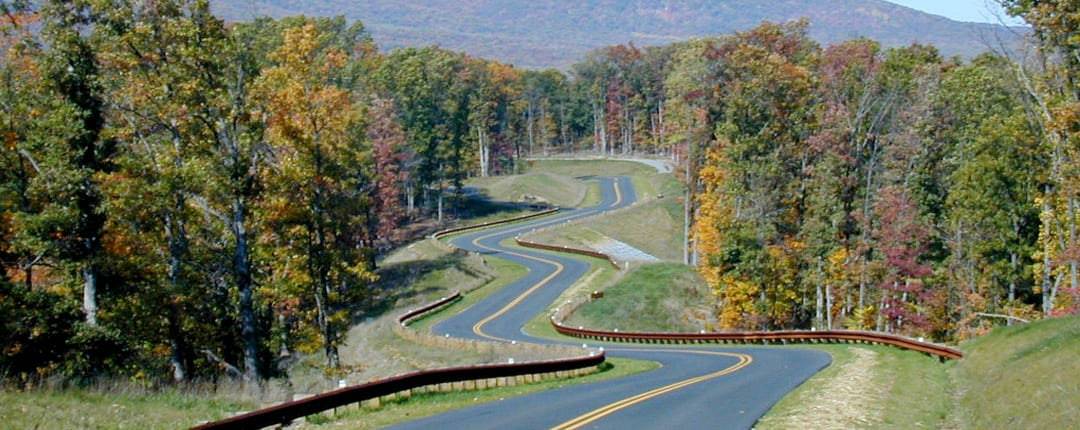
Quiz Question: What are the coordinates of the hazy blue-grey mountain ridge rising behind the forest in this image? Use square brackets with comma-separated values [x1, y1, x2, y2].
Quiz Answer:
[212, 0, 1025, 68]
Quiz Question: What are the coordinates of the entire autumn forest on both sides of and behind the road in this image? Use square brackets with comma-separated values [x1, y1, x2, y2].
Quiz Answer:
[0, 0, 1080, 385]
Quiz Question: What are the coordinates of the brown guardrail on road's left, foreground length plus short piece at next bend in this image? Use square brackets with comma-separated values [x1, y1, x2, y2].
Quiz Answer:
[193, 293, 605, 430]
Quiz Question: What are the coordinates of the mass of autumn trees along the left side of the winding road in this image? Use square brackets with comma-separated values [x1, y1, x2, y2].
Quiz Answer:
[0, 0, 600, 384]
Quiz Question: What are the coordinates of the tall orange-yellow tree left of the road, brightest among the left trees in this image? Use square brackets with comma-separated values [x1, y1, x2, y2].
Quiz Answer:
[258, 23, 375, 368]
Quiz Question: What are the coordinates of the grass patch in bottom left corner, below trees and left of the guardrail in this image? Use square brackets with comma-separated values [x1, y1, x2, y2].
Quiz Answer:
[0, 388, 257, 429]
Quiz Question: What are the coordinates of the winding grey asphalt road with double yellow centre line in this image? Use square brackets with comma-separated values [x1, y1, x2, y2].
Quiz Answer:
[395, 177, 829, 430]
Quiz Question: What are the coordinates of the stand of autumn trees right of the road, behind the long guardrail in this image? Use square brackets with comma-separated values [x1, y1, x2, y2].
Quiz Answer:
[666, 1, 1080, 340]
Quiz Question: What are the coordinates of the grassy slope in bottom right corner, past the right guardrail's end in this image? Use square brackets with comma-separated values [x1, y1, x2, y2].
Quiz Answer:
[950, 317, 1080, 429]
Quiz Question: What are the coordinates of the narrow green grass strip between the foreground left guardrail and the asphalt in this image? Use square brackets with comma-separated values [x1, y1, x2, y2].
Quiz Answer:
[319, 358, 659, 429]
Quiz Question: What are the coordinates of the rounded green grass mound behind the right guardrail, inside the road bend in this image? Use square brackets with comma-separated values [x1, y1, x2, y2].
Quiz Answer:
[566, 263, 714, 332]
